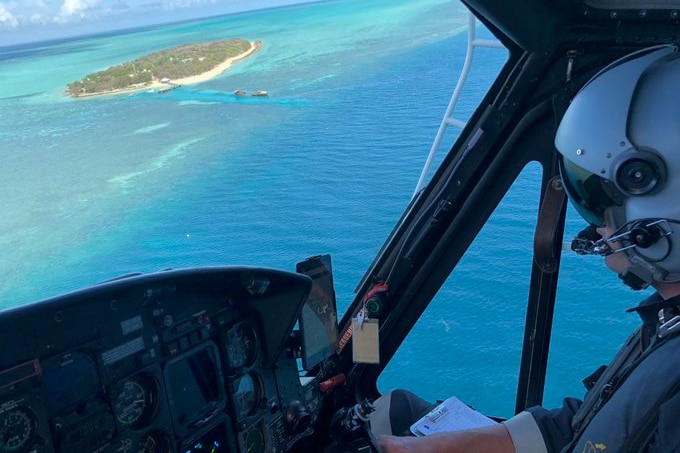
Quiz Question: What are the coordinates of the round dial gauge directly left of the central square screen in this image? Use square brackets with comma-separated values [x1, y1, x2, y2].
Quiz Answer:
[113, 374, 158, 429]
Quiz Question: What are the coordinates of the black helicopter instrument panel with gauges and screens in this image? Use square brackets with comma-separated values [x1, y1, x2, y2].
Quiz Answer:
[0, 267, 321, 453]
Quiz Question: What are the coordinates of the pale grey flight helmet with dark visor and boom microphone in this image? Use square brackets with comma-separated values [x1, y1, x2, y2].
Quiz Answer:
[555, 46, 680, 289]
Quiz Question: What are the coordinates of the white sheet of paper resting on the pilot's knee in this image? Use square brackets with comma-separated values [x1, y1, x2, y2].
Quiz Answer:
[411, 396, 496, 436]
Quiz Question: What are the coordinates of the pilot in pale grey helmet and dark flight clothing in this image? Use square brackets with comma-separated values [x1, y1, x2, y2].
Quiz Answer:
[371, 46, 680, 453]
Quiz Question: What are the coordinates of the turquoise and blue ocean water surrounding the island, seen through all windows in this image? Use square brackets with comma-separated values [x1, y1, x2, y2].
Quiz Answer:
[0, 0, 639, 416]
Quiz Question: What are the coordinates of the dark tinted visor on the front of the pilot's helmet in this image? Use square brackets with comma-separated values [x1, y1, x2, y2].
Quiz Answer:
[559, 155, 620, 227]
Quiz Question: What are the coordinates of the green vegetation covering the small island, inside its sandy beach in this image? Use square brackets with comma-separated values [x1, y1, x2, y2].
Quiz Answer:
[67, 38, 254, 97]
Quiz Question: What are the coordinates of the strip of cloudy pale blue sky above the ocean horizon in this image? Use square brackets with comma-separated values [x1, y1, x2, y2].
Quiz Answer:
[0, 0, 309, 47]
